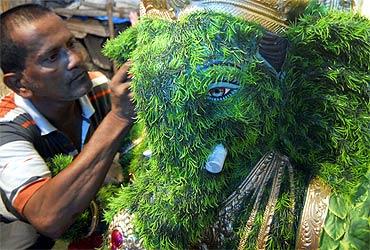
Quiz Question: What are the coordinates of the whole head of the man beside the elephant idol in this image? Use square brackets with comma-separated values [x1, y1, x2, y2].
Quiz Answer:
[1, 4, 91, 100]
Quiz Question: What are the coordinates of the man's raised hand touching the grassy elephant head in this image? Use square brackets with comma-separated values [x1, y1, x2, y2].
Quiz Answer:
[109, 62, 135, 122]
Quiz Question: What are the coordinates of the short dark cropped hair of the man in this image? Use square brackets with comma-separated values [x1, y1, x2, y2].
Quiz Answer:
[0, 4, 53, 74]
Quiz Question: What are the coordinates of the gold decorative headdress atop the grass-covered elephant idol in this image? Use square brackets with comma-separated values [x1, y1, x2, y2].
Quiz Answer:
[140, 0, 308, 33]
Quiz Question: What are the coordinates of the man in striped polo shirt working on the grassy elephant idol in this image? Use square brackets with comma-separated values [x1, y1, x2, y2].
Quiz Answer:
[0, 5, 134, 249]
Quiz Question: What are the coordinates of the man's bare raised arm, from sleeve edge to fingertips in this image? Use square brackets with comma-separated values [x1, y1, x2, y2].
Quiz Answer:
[23, 64, 134, 238]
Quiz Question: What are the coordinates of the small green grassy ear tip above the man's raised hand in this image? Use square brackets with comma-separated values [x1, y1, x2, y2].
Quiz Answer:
[103, 26, 138, 65]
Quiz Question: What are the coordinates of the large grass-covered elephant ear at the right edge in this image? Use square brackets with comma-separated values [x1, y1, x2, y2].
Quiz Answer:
[285, 0, 370, 199]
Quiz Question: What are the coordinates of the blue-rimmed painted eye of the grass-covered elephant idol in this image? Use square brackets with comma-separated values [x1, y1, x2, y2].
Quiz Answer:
[207, 81, 239, 101]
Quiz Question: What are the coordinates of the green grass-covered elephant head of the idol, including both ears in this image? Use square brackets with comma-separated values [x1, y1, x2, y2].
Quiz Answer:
[105, 1, 370, 249]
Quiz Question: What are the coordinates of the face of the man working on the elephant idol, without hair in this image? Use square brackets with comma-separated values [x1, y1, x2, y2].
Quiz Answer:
[12, 14, 92, 101]
